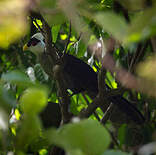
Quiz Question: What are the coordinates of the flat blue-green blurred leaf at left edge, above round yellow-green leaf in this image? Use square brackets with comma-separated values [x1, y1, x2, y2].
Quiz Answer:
[1, 70, 34, 86]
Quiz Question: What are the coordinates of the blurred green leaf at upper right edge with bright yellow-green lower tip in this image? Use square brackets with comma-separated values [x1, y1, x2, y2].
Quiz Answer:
[124, 7, 156, 44]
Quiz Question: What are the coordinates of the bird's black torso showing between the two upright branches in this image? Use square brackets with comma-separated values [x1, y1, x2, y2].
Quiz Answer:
[62, 54, 98, 96]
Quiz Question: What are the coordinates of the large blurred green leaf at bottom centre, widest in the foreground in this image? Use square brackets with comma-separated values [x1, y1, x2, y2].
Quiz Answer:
[47, 120, 110, 155]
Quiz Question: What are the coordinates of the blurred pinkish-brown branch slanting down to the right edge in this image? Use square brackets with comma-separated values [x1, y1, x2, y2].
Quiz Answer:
[90, 38, 156, 97]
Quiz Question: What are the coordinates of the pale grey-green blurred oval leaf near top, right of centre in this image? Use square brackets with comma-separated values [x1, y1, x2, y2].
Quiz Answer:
[95, 12, 128, 41]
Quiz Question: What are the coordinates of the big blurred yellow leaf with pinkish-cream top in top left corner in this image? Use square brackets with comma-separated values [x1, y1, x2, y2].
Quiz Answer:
[0, 0, 28, 48]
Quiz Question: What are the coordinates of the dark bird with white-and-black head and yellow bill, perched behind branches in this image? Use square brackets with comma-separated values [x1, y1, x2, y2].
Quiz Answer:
[23, 32, 145, 124]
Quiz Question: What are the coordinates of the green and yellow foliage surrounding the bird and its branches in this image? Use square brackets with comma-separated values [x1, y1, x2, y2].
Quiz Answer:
[0, 0, 156, 155]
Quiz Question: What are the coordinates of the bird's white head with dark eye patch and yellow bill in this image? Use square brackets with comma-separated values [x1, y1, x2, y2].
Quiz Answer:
[23, 33, 45, 55]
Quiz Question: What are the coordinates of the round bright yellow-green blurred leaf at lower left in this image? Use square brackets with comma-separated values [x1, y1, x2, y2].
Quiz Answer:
[20, 88, 48, 115]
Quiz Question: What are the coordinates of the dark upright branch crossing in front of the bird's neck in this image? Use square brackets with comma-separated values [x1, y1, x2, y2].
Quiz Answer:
[30, 11, 72, 155]
